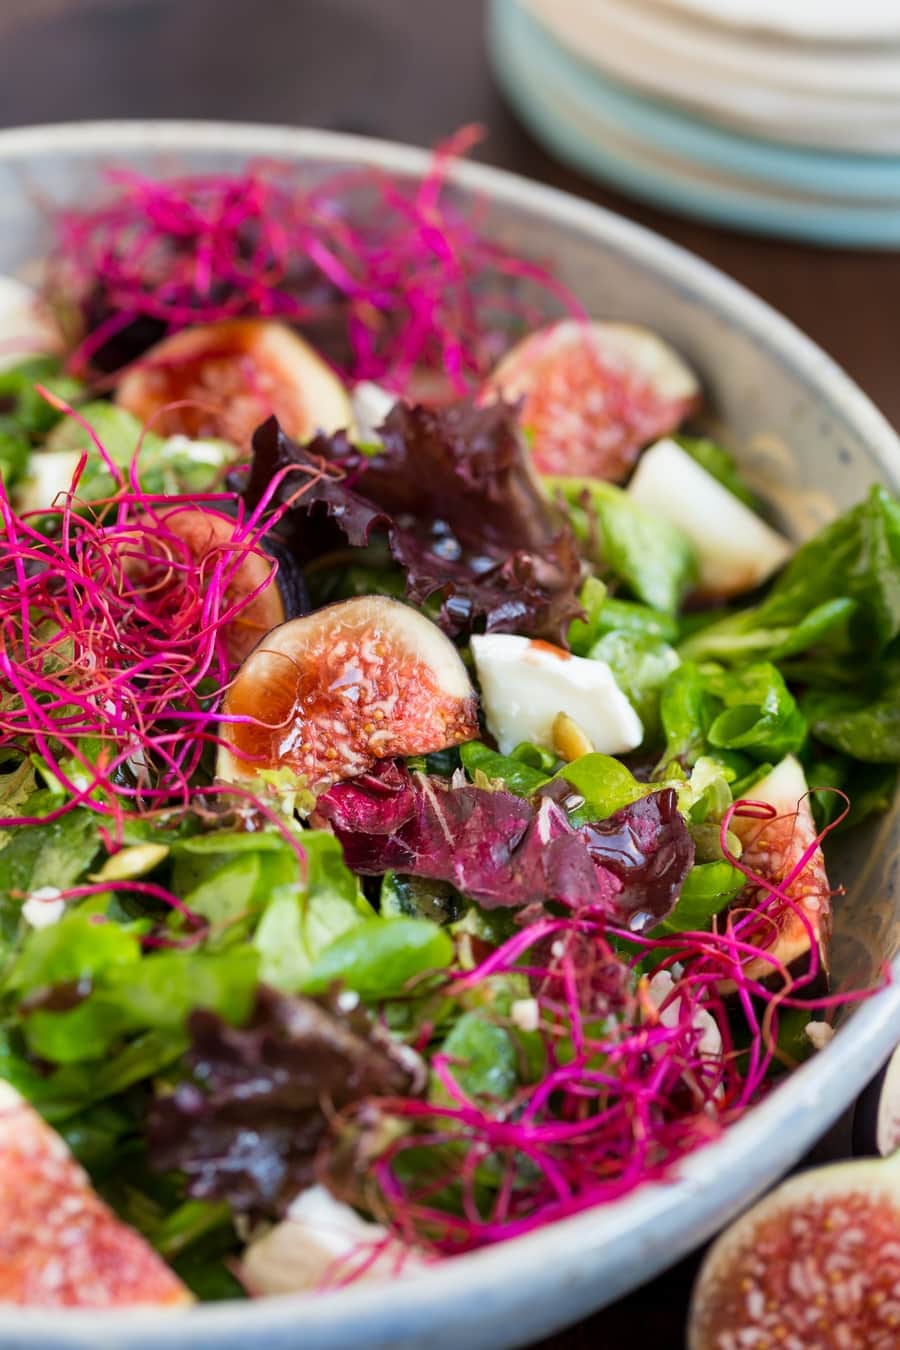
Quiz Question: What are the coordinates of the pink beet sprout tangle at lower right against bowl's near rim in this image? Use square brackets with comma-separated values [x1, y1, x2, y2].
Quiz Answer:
[329, 802, 873, 1254]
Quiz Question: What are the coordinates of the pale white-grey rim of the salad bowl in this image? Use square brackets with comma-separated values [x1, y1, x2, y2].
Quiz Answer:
[0, 120, 900, 1350]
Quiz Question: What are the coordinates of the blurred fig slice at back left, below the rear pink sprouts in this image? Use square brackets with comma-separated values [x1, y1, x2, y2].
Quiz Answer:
[116, 319, 352, 450]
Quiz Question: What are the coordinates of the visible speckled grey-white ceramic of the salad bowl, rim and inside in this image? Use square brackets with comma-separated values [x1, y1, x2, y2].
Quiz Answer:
[0, 122, 900, 1350]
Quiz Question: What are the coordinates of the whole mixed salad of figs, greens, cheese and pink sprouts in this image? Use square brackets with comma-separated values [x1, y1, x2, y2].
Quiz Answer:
[0, 131, 900, 1307]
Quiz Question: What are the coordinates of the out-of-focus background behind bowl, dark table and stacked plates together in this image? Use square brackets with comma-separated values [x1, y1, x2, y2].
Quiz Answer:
[0, 0, 900, 424]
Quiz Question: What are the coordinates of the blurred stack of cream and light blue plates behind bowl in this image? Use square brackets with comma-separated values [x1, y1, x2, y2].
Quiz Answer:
[488, 0, 900, 248]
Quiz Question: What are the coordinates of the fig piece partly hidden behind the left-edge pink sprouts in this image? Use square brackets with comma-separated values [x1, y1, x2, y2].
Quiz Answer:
[131, 506, 305, 666]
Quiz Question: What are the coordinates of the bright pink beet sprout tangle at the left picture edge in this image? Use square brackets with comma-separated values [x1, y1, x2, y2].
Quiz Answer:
[0, 410, 319, 842]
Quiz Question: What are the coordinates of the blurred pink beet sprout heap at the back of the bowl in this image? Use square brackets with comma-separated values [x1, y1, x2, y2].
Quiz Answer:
[50, 127, 583, 393]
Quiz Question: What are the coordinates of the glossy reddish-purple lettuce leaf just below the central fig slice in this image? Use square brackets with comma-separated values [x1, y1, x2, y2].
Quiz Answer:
[316, 763, 694, 932]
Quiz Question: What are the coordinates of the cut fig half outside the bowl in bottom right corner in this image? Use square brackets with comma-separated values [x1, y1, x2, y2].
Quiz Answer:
[687, 1154, 900, 1350]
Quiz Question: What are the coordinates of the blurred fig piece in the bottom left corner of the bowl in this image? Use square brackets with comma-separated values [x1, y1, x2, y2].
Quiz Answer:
[0, 1081, 190, 1308]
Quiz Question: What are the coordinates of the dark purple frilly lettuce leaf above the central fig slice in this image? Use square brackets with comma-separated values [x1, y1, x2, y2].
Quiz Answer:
[235, 404, 582, 641]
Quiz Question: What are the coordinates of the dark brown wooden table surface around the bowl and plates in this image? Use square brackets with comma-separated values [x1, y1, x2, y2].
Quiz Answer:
[0, 0, 900, 1350]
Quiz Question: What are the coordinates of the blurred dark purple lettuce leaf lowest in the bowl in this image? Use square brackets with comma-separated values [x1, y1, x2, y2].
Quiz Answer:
[147, 987, 421, 1218]
